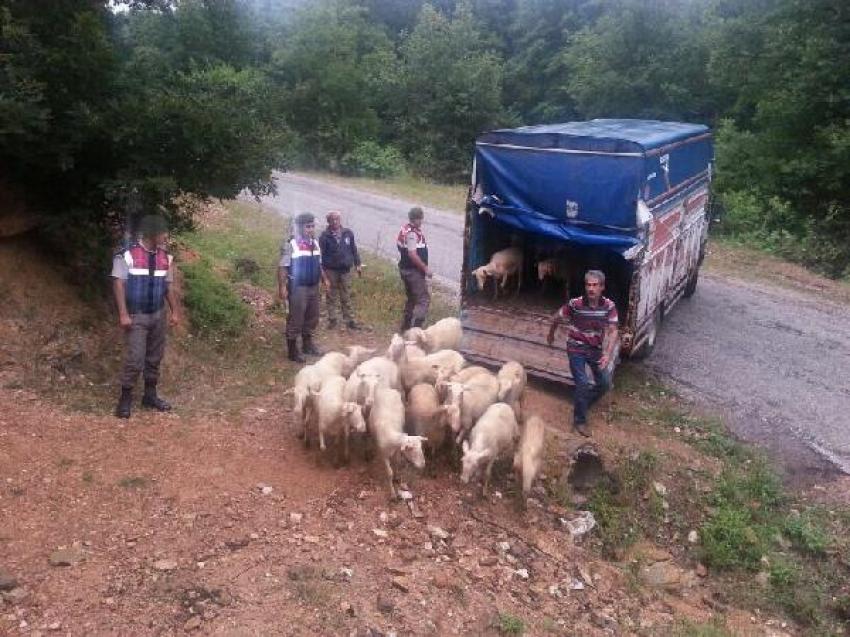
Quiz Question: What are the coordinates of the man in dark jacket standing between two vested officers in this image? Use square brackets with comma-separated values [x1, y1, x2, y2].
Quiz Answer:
[319, 210, 363, 330]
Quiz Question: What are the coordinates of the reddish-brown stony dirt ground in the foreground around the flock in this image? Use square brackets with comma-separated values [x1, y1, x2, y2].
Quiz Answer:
[0, 231, 840, 636]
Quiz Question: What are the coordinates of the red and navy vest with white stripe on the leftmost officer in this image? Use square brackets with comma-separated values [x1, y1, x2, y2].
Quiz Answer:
[118, 243, 174, 314]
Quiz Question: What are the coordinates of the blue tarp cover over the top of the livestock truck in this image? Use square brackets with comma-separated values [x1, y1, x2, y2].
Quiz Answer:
[474, 119, 713, 251]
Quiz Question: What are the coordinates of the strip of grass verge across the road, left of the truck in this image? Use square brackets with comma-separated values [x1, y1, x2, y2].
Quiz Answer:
[306, 172, 468, 215]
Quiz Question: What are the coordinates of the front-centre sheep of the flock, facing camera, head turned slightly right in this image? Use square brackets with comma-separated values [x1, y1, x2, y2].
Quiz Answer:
[369, 387, 425, 498]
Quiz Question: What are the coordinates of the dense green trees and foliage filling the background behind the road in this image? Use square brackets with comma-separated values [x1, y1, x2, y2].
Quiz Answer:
[0, 0, 850, 276]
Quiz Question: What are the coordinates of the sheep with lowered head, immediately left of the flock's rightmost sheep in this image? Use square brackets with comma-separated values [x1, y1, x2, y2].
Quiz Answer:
[460, 403, 519, 496]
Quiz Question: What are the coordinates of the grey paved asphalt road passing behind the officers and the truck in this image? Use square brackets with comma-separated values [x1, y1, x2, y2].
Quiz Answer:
[264, 174, 850, 477]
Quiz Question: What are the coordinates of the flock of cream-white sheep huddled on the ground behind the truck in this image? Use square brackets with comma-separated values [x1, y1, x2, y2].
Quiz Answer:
[291, 318, 546, 503]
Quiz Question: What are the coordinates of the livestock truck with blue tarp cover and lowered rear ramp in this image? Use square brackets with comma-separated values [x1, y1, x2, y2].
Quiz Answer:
[460, 119, 713, 383]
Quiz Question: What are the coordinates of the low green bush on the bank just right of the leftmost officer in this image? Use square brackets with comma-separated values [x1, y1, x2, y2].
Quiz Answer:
[180, 259, 250, 336]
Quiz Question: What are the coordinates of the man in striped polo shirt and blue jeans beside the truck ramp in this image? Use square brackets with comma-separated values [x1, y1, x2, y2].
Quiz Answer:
[546, 270, 618, 436]
